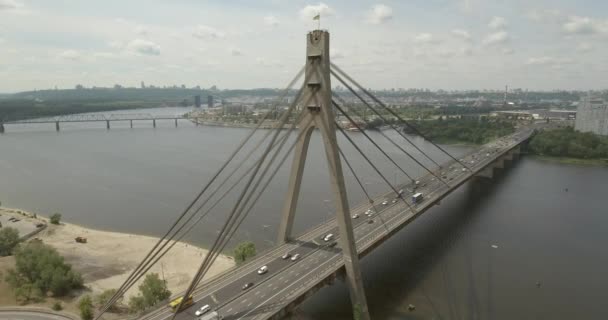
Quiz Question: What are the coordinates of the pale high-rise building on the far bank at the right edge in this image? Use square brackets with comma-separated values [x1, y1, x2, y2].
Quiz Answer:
[574, 96, 608, 136]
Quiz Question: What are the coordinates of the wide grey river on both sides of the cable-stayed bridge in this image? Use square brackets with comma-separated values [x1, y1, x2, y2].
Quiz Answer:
[0, 108, 608, 320]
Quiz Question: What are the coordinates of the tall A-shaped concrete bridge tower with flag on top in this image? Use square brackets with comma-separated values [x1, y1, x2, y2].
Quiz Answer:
[278, 30, 370, 320]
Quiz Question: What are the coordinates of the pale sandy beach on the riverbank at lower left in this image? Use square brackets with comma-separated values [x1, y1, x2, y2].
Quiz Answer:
[0, 208, 234, 301]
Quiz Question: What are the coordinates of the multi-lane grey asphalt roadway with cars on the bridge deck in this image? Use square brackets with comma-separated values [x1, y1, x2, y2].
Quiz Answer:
[143, 129, 532, 320]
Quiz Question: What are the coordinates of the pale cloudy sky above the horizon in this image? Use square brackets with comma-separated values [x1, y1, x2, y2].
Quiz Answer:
[0, 0, 608, 93]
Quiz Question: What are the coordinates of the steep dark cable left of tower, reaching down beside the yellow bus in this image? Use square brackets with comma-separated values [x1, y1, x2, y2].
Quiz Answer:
[172, 86, 312, 319]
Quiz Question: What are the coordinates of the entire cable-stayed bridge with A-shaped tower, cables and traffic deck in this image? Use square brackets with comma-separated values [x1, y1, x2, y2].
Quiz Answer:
[97, 30, 533, 320]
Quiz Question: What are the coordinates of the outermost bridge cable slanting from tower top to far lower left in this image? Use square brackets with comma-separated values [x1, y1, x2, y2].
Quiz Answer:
[95, 68, 304, 320]
